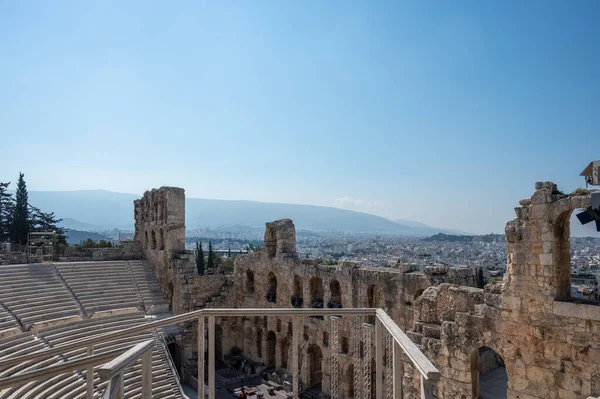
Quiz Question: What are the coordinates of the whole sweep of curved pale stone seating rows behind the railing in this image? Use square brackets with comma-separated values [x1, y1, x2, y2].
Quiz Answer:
[0, 261, 184, 399]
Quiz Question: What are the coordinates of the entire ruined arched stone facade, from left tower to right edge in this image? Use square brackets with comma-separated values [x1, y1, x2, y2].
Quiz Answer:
[136, 183, 600, 399]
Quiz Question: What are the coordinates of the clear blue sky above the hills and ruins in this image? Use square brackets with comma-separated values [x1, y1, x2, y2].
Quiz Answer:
[0, 0, 600, 233]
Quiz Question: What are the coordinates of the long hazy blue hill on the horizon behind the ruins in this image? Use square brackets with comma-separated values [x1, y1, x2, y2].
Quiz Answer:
[29, 190, 464, 236]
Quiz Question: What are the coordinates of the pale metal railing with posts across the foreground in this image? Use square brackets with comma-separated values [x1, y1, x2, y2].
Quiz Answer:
[0, 308, 440, 399]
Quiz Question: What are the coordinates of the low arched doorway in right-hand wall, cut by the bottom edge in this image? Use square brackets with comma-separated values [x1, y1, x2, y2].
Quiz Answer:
[471, 346, 508, 399]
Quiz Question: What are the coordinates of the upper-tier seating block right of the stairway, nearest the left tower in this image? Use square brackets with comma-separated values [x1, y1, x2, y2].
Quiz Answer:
[55, 262, 140, 316]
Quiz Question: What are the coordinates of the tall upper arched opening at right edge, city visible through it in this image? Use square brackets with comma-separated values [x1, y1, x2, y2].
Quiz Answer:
[556, 209, 600, 304]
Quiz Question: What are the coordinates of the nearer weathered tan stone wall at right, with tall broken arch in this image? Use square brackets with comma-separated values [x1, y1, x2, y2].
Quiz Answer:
[411, 183, 600, 399]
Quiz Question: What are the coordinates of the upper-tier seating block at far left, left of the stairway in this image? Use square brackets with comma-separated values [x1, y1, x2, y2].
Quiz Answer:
[0, 264, 81, 329]
